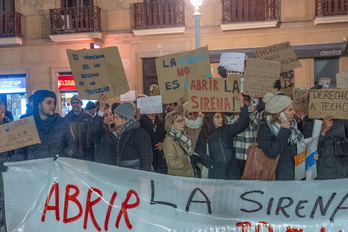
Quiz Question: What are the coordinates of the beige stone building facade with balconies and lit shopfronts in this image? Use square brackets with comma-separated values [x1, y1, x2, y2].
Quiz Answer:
[0, 0, 348, 115]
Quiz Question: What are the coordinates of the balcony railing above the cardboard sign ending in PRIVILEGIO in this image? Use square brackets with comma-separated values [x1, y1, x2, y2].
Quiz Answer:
[50, 6, 101, 34]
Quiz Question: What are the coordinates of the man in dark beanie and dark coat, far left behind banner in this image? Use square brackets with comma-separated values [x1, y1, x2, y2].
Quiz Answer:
[11, 90, 76, 161]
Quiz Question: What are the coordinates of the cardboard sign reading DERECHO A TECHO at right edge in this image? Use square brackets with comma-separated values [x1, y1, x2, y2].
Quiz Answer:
[308, 89, 348, 119]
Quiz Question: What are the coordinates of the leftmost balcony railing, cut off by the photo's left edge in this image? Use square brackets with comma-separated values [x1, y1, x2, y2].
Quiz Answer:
[0, 11, 22, 37]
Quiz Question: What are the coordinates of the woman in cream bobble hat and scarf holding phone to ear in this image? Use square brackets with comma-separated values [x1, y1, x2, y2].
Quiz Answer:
[257, 93, 305, 180]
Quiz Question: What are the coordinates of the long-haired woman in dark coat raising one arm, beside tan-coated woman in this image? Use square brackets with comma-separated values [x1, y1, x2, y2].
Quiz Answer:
[196, 94, 249, 180]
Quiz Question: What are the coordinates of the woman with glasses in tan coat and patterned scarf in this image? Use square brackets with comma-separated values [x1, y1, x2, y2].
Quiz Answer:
[163, 111, 199, 177]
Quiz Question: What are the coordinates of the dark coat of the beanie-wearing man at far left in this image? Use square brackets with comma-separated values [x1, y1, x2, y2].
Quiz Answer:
[11, 114, 77, 161]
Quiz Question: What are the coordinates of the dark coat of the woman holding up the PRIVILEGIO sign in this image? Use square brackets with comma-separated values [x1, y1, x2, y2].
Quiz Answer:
[88, 114, 117, 165]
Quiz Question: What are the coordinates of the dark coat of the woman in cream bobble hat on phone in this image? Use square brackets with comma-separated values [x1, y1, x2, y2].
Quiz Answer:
[257, 120, 297, 180]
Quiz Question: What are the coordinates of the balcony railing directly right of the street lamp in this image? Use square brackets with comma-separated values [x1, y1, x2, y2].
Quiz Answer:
[221, 0, 280, 23]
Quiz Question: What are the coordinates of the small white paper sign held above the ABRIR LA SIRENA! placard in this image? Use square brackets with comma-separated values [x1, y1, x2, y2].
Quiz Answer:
[220, 52, 245, 72]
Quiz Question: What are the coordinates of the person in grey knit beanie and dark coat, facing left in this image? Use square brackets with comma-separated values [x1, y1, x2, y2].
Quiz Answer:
[114, 102, 153, 171]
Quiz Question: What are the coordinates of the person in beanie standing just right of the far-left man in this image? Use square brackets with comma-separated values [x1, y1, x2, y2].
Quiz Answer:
[64, 95, 94, 160]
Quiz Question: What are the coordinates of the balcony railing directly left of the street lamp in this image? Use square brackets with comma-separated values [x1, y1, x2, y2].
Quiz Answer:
[131, 0, 185, 29]
